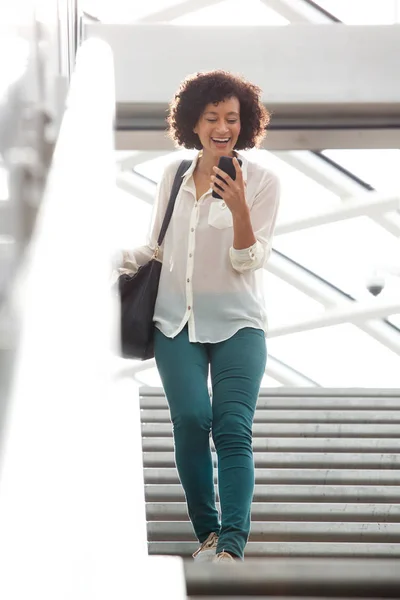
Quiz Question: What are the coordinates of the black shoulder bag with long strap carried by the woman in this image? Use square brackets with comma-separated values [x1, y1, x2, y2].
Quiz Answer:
[118, 160, 192, 360]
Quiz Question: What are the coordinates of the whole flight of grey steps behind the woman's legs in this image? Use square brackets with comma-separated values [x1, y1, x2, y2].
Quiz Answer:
[141, 388, 400, 568]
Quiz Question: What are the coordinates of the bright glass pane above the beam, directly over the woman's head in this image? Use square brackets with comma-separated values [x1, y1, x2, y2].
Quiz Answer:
[171, 0, 289, 27]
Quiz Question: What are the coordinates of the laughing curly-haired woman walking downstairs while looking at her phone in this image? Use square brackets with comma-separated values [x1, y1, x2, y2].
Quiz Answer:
[120, 71, 279, 562]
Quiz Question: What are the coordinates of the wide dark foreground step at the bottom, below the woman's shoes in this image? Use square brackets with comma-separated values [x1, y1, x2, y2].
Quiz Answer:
[184, 557, 400, 600]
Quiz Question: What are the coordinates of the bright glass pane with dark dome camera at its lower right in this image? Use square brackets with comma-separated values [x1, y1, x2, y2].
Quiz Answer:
[274, 217, 400, 300]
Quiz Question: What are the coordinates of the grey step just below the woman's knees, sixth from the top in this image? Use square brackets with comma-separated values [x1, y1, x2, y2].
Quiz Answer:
[143, 451, 400, 470]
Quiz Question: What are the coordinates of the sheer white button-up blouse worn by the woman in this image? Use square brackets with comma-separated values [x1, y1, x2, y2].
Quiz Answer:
[118, 150, 279, 343]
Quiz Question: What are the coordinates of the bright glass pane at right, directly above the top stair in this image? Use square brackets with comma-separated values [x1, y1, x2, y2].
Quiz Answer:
[268, 324, 400, 388]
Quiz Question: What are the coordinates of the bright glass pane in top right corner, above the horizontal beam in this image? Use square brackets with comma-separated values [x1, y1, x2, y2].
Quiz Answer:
[318, 0, 400, 25]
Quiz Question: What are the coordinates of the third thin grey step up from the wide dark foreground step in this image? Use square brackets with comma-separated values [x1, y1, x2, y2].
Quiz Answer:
[146, 502, 400, 523]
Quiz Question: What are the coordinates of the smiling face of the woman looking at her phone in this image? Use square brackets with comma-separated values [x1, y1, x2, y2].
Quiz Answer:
[193, 97, 240, 157]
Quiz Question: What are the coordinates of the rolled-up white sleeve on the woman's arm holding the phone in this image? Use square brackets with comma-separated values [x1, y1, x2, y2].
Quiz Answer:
[229, 173, 280, 273]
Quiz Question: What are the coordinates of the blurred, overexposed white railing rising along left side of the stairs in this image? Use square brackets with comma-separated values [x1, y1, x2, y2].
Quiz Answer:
[0, 39, 185, 600]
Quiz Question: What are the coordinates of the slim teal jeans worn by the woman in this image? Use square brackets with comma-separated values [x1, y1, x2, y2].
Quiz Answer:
[155, 327, 267, 559]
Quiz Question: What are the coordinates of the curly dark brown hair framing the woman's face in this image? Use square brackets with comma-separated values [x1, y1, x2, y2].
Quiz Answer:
[167, 70, 270, 150]
